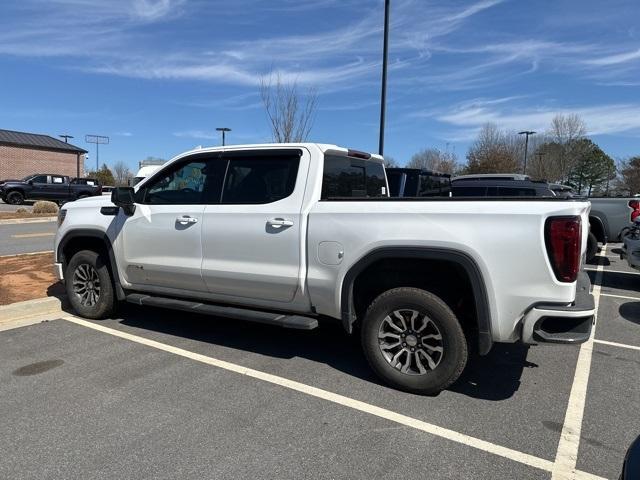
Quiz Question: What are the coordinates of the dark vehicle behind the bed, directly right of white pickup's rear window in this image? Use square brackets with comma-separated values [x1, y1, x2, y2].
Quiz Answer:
[386, 168, 451, 197]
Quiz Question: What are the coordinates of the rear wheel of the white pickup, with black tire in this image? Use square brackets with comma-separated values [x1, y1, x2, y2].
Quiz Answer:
[361, 287, 468, 395]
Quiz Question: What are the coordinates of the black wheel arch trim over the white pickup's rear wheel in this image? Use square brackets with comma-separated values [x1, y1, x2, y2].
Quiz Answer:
[340, 247, 493, 355]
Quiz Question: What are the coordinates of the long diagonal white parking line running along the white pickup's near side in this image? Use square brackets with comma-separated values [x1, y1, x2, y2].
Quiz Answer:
[63, 316, 602, 480]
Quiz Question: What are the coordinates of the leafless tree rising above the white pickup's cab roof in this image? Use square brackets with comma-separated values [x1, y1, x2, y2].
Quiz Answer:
[260, 73, 318, 143]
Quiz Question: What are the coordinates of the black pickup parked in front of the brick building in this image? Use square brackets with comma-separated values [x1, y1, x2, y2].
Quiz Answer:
[0, 173, 101, 205]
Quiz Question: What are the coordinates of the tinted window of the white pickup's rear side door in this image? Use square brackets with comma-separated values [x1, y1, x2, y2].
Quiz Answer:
[222, 155, 300, 204]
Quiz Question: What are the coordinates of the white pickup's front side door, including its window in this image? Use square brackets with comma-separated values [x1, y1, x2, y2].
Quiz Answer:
[120, 155, 224, 294]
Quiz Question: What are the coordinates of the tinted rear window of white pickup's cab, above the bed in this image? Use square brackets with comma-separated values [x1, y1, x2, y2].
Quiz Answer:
[322, 155, 387, 200]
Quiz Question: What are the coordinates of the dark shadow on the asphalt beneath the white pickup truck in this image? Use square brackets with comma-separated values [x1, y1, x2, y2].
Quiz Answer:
[118, 305, 537, 401]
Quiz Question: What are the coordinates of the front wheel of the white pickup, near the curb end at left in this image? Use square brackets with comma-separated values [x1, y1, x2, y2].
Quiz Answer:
[65, 250, 115, 319]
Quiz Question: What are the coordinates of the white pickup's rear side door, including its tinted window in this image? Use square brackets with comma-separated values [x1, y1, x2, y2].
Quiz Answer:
[202, 149, 309, 302]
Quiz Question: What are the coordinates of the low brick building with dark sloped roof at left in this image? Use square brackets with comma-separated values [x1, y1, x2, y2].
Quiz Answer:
[0, 129, 87, 179]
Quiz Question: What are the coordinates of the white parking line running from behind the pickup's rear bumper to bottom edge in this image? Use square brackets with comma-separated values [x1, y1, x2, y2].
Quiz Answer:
[551, 245, 607, 480]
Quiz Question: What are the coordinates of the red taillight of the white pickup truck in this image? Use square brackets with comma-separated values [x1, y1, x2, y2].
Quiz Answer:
[544, 217, 582, 283]
